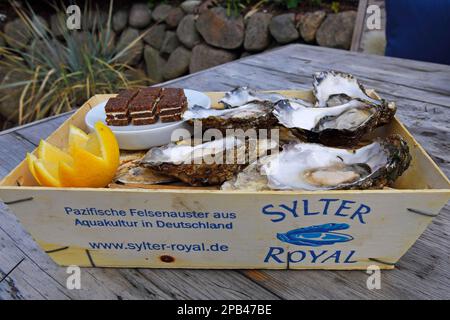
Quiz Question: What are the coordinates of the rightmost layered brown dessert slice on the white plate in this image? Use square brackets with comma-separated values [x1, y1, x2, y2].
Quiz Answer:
[158, 88, 187, 122]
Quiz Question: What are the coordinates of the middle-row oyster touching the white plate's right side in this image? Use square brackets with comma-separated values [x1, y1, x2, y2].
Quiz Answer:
[183, 101, 277, 132]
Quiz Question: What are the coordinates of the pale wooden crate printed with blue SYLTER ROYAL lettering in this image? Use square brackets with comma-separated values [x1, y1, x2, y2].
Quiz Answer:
[0, 91, 450, 270]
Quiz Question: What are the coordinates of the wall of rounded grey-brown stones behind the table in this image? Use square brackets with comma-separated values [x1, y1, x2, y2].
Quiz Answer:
[1, 0, 356, 82]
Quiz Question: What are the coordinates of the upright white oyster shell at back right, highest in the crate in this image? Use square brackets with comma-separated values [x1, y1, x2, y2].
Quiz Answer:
[313, 70, 384, 108]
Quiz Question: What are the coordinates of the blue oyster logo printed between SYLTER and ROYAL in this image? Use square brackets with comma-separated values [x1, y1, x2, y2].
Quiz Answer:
[277, 223, 353, 247]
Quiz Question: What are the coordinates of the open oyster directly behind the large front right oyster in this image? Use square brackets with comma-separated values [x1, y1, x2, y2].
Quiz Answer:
[273, 100, 395, 146]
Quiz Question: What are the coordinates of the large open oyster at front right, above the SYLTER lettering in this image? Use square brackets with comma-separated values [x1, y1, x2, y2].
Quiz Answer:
[260, 135, 411, 190]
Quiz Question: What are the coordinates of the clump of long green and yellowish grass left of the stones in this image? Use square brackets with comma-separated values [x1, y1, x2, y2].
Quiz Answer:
[0, 0, 149, 124]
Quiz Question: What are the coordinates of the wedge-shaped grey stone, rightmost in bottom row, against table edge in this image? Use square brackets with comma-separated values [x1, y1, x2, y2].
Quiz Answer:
[189, 44, 238, 73]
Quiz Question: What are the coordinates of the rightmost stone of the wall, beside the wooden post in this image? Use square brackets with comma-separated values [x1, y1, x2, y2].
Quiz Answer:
[316, 11, 356, 50]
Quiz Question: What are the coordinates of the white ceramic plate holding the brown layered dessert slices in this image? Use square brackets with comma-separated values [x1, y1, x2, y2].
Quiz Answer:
[85, 89, 211, 150]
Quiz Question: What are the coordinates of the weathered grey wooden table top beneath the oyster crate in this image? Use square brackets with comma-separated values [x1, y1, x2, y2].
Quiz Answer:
[0, 44, 450, 299]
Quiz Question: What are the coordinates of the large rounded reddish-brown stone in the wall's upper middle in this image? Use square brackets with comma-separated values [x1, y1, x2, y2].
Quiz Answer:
[195, 7, 245, 49]
